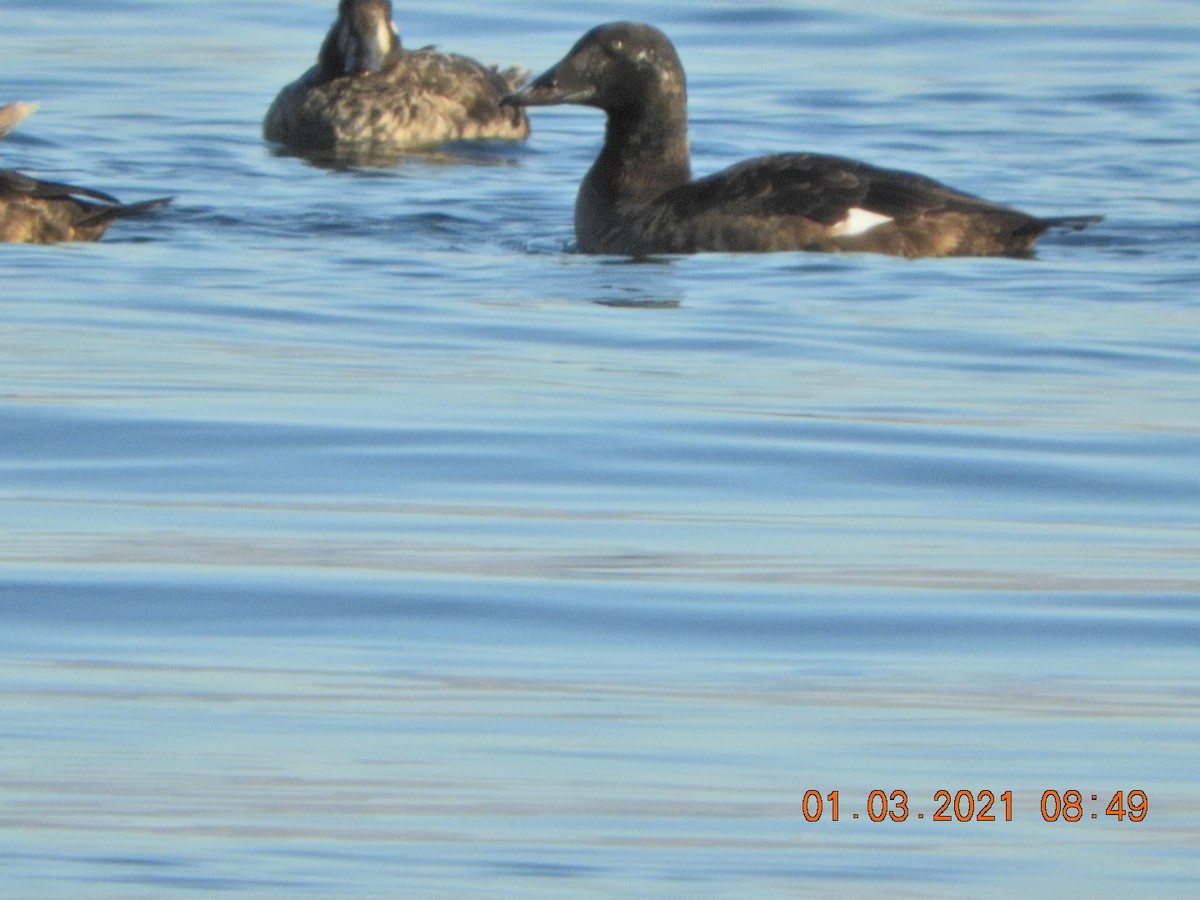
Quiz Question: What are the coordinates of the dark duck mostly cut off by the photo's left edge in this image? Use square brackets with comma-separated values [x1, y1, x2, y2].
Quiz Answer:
[0, 103, 170, 244]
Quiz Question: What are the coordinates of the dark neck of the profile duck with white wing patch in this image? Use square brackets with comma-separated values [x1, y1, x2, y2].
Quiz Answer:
[584, 96, 691, 205]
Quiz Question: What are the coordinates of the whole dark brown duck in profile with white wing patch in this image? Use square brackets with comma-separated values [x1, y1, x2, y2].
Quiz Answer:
[506, 22, 1099, 257]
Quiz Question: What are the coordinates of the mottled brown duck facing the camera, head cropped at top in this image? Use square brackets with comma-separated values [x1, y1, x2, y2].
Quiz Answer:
[263, 0, 529, 156]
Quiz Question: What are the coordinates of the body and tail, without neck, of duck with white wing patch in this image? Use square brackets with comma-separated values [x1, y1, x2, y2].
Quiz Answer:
[575, 154, 1098, 257]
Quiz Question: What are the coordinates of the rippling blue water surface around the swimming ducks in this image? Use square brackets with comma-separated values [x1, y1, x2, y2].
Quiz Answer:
[0, 0, 1200, 899]
